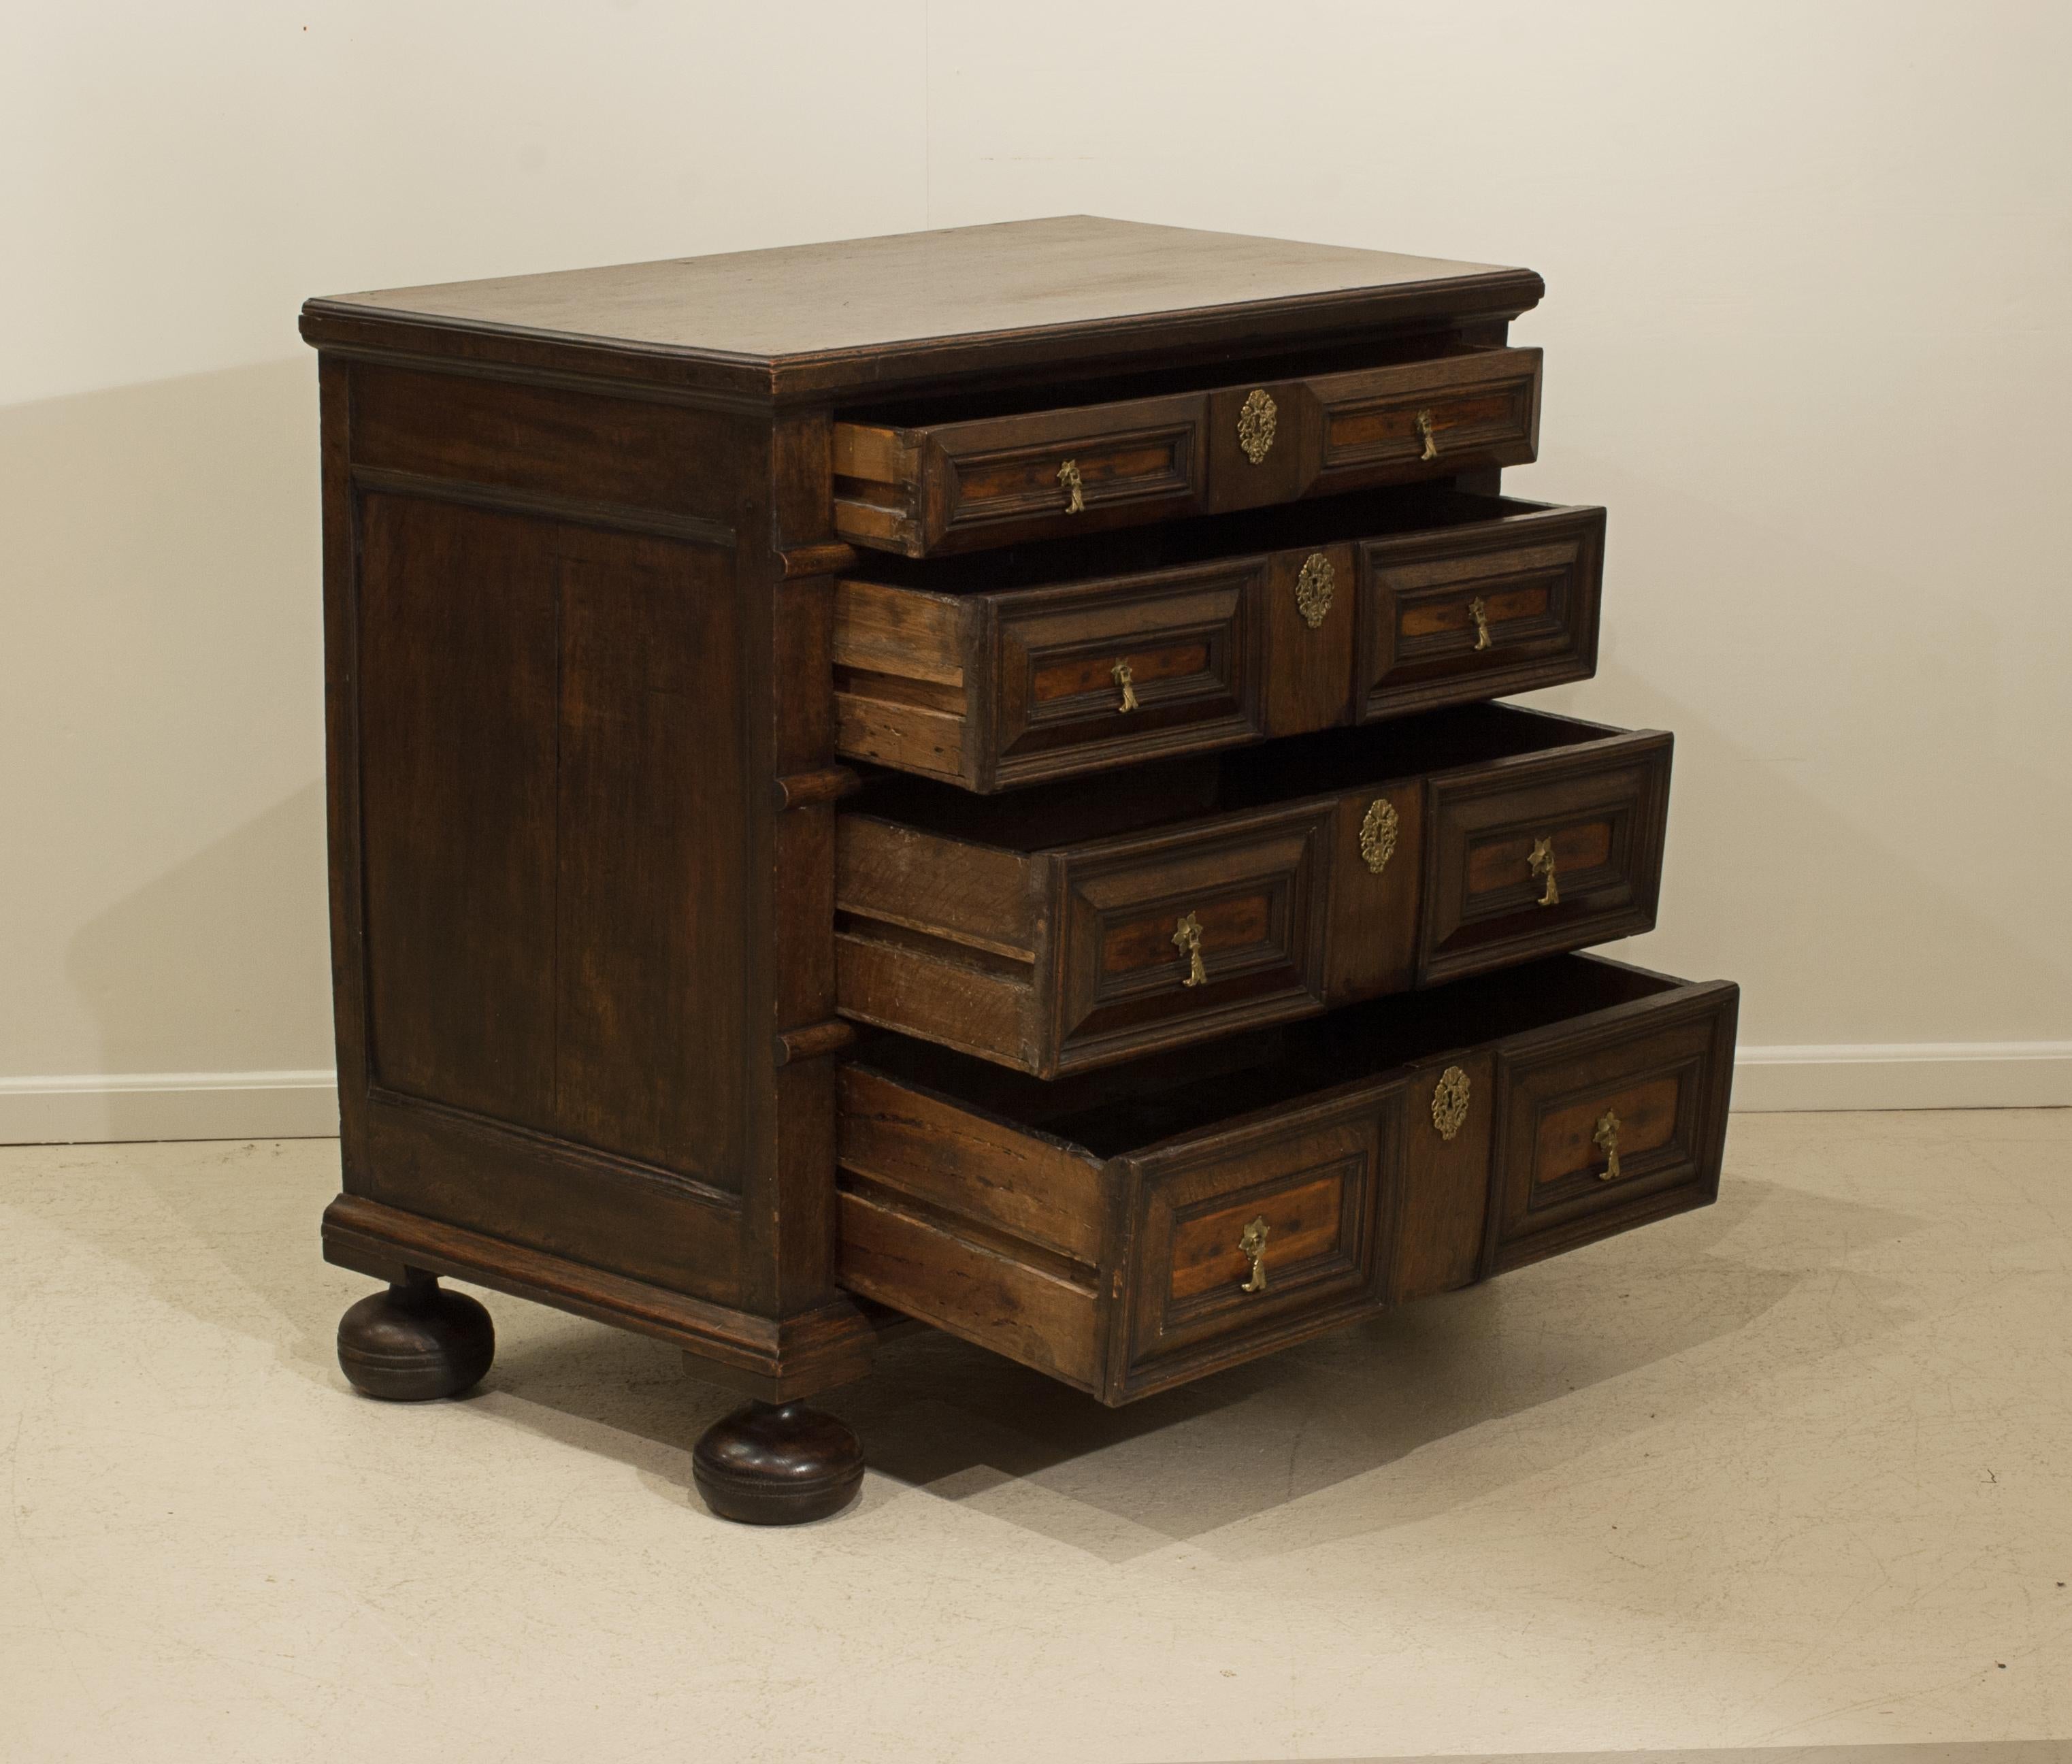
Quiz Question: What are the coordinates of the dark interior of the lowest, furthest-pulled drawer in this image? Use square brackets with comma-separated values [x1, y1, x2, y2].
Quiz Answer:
[856, 956, 1685, 1159]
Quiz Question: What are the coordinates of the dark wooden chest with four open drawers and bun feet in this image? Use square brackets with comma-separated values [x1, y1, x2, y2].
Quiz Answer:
[303, 218, 1737, 1522]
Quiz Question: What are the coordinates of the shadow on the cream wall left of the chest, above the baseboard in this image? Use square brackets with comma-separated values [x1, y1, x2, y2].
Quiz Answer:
[0, 355, 331, 1136]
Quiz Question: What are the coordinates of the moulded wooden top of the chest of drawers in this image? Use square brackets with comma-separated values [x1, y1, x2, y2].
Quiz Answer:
[303, 216, 1541, 398]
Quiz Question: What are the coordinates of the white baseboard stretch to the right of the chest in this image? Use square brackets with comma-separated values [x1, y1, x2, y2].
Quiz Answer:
[1734, 1041, 2072, 1113]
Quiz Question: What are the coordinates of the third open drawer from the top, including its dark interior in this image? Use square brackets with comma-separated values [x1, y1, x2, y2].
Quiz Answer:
[835, 705, 1670, 1078]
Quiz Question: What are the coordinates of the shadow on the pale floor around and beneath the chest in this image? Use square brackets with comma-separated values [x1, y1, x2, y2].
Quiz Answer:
[28, 1140, 1925, 1561]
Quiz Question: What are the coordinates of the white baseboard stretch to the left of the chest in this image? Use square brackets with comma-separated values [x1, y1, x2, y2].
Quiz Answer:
[0, 1068, 338, 1146]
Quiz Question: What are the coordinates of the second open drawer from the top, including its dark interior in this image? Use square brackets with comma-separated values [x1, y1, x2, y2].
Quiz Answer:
[833, 489, 1604, 789]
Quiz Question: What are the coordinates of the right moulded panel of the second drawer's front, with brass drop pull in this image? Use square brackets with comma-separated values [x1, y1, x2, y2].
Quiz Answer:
[1355, 508, 1604, 721]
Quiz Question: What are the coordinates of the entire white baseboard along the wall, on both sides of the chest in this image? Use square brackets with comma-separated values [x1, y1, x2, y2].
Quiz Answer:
[0, 1041, 2072, 1146]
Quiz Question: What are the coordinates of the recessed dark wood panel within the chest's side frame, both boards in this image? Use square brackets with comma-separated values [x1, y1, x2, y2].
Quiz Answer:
[359, 491, 746, 1205]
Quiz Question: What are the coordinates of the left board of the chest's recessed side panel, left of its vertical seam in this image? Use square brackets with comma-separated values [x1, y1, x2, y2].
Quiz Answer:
[359, 495, 559, 1128]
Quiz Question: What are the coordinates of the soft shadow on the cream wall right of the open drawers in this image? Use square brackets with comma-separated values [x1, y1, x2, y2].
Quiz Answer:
[1521, 460, 2072, 1045]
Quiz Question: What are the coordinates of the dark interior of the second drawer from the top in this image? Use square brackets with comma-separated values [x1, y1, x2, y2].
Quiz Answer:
[845, 483, 1550, 595]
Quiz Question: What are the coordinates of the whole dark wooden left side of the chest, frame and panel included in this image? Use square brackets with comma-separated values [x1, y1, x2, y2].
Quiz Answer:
[323, 361, 766, 1309]
